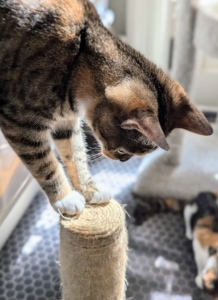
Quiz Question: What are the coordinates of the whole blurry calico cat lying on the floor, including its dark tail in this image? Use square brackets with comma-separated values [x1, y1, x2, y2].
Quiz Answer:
[134, 192, 218, 297]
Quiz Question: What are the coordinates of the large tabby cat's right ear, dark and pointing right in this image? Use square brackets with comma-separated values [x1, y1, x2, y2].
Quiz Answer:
[173, 98, 213, 135]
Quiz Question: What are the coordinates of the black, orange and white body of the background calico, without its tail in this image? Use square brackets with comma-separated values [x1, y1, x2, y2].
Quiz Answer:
[184, 192, 218, 297]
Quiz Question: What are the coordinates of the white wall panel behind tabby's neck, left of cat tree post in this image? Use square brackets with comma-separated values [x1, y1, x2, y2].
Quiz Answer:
[126, 0, 172, 72]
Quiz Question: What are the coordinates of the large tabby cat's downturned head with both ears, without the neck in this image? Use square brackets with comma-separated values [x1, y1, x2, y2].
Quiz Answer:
[80, 79, 212, 161]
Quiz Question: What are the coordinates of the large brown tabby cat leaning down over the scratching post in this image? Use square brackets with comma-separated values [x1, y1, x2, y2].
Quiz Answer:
[0, 0, 212, 215]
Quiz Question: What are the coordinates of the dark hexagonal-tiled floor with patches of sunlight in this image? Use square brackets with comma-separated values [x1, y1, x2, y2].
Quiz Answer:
[0, 158, 211, 300]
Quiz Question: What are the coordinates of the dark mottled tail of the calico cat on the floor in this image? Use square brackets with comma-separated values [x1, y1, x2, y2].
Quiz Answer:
[133, 196, 187, 225]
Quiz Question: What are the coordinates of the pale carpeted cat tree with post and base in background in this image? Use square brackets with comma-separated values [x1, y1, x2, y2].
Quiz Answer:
[133, 0, 218, 200]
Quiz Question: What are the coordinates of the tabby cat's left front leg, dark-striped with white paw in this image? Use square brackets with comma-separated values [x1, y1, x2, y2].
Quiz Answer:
[2, 126, 85, 215]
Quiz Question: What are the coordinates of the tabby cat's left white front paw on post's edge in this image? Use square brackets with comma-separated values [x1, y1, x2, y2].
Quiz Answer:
[52, 191, 86, 215]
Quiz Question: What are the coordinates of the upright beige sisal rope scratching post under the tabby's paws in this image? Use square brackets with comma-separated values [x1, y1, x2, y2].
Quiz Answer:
[60, 200, 127, 300]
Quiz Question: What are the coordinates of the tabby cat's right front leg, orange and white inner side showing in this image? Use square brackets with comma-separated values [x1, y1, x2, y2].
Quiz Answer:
[52, 119, 111, 204]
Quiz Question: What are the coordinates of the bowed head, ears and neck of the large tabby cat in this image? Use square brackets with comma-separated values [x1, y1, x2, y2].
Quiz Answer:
[76, 32, 212, 161]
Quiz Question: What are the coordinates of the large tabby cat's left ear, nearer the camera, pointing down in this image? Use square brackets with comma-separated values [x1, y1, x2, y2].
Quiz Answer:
[120, 116, 170, 151]
